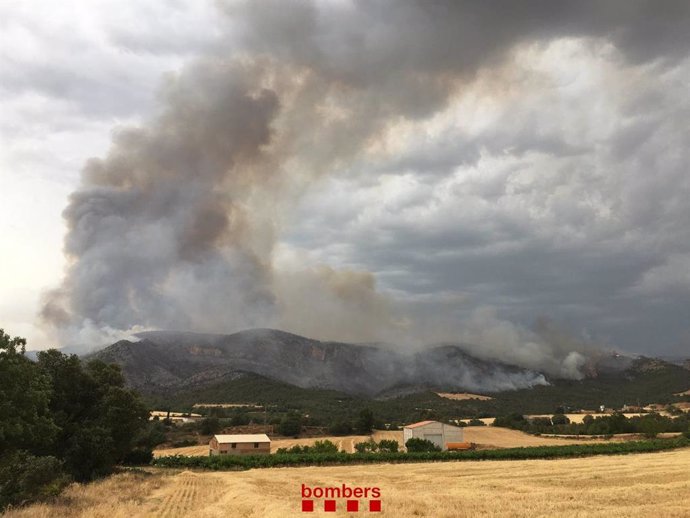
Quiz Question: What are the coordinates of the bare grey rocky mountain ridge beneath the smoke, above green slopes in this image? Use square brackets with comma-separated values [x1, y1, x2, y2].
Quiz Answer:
[91, 329, 547, 396]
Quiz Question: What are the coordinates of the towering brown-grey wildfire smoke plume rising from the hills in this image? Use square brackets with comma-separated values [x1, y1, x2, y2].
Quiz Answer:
[43, 0, 690, 377]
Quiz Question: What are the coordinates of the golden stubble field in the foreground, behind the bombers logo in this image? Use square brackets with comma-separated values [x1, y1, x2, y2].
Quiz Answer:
[7, 448, 690, 518]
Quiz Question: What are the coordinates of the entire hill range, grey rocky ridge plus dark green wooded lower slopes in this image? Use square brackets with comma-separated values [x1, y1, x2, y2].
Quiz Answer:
[90, 330, 690, 423]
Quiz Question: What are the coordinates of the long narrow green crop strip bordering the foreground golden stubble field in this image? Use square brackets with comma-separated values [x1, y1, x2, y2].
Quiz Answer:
[153, 437, 690, 471]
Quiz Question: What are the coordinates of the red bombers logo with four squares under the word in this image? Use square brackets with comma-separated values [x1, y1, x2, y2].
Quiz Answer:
[301, 484, 381, 513]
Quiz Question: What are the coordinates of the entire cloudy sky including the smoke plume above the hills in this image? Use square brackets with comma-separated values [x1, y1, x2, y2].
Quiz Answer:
[0, 0, 690, 372]
